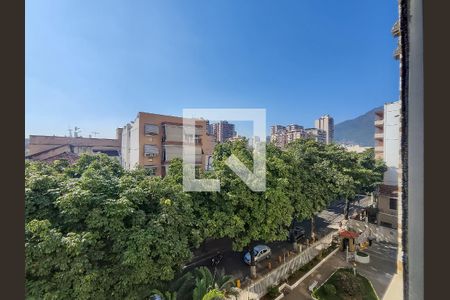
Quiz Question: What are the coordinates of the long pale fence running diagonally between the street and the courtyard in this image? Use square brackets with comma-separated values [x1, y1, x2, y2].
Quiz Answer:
[246, 231, 337, 297]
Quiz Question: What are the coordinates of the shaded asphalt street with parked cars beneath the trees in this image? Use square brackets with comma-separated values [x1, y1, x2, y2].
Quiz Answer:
[187, 197, 370, 283]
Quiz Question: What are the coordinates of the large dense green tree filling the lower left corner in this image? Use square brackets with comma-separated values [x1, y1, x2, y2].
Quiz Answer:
[25, 155, 199, 299]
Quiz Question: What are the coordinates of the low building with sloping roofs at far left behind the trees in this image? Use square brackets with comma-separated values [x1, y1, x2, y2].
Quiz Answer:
[25, 134, 121, 163]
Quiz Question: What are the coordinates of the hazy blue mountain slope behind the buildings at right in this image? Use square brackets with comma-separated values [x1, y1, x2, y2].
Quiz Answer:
[334, 106, 383, 147]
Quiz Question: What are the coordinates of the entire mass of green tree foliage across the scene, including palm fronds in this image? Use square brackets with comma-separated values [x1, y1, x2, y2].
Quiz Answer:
[25, 140, 385, 299]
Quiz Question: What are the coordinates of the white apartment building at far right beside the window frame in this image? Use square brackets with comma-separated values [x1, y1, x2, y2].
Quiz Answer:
[374, 101, 401, 228]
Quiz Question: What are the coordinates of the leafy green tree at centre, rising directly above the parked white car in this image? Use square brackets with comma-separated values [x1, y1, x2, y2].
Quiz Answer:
[208, 140, 294, 276]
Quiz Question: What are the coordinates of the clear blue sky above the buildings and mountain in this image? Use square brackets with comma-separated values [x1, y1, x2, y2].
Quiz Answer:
[25, 0, 399, 137]
